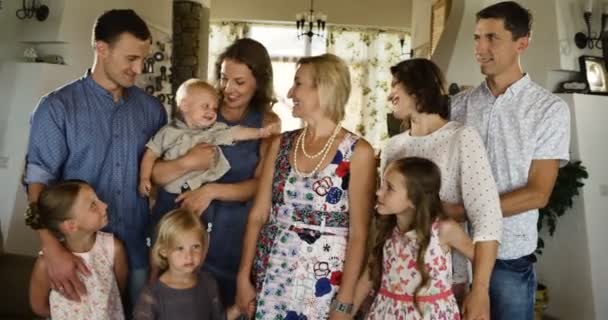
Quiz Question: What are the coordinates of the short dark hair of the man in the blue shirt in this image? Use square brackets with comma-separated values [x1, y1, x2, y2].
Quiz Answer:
[93, 9, 152, 45]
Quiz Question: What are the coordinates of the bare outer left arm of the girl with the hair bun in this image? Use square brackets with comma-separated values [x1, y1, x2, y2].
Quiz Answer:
[30, 256, 51, 318]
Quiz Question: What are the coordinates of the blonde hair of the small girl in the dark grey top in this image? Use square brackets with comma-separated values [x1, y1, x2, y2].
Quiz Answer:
[152, 209, 208, 270]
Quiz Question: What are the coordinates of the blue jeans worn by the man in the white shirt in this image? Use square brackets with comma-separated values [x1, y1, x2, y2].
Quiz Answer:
[490, 255, 536, 320]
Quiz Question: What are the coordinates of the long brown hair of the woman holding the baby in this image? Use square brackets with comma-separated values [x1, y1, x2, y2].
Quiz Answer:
[215, 38, 277, 111]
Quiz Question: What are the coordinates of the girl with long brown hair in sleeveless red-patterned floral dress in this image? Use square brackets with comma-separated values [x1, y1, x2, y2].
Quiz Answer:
[355, 157, 474, 320]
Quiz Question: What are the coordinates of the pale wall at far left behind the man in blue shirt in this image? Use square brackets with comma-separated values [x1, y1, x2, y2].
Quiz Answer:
[0, 0, 173, 253]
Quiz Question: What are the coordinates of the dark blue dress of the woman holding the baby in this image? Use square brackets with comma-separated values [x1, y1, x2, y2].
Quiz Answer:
[202, 110, 263, 306]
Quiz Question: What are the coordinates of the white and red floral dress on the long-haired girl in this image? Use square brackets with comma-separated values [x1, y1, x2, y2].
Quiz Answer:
[367, 220, 460, 320]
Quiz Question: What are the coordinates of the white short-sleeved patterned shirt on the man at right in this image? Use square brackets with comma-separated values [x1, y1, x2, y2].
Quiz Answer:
[451, 75, 570, 259]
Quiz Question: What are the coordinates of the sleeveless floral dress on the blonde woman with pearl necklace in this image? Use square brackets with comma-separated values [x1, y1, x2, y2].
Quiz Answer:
[253, 131, 359, 320]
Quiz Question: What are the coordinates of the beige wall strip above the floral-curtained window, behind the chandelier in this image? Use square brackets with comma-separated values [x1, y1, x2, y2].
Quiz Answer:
[211, 0, 411, 29]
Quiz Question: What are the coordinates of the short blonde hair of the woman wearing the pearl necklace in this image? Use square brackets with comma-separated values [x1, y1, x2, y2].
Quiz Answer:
[298, 53, 351, 122]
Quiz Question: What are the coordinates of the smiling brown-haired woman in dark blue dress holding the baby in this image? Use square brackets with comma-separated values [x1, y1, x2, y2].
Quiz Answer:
[153, 38, 280, 305]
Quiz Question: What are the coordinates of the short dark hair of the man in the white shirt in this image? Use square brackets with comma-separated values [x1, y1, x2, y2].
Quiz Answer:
[476, 1, 533, 40]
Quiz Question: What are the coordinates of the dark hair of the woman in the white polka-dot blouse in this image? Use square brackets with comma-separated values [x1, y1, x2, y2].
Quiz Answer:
[391, 58, 450, 122]
